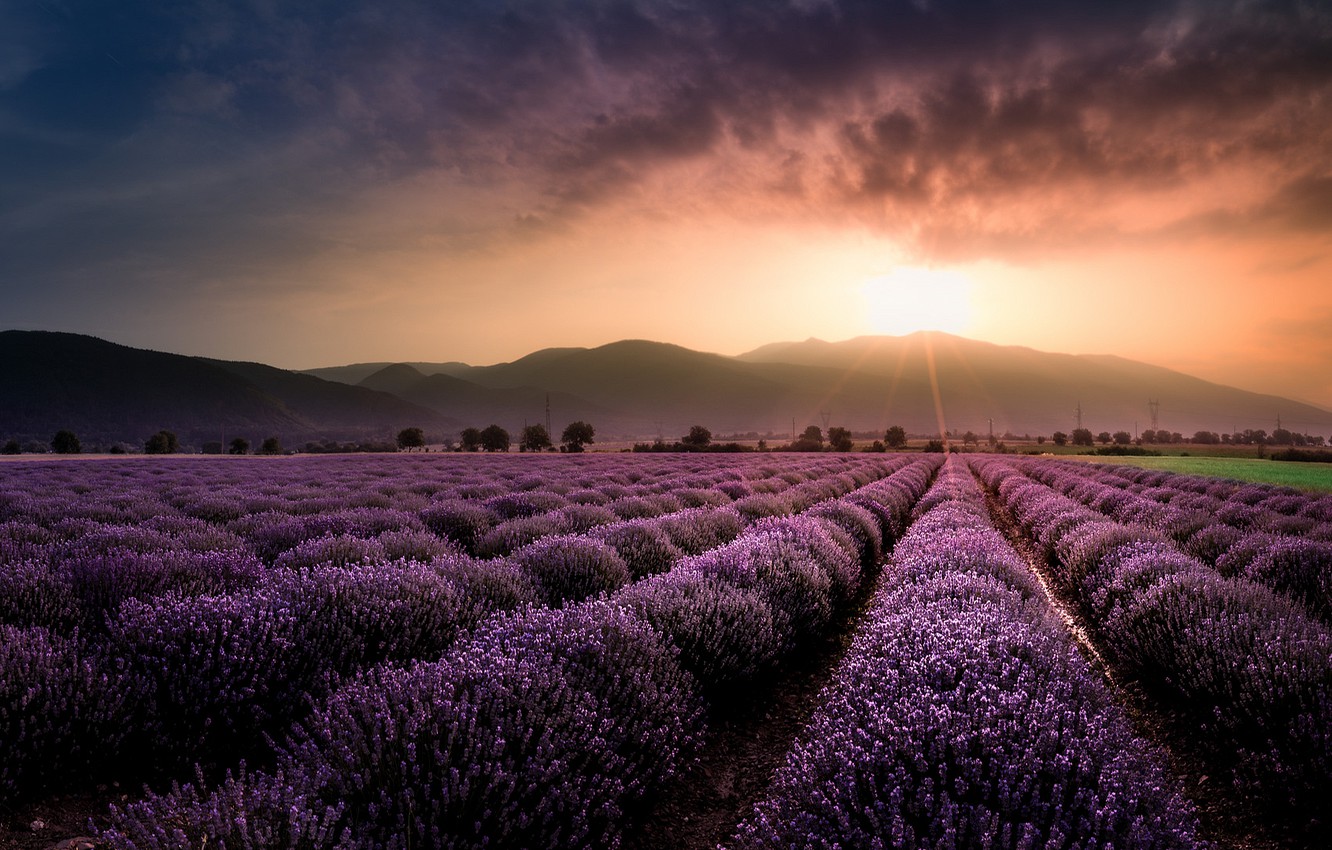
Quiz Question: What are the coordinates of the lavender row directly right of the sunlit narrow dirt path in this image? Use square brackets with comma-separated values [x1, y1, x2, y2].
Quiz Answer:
[975, 458, 1332, 833]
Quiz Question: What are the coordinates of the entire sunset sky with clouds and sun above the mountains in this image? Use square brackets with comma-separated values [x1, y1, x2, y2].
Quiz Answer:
[0, 0, 1332, 409]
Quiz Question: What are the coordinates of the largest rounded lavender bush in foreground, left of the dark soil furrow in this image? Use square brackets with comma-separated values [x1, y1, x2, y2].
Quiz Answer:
[277, 605, 701, 847]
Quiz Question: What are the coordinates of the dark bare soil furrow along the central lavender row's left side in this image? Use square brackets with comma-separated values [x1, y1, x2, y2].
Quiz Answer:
[623, 570, 879, 850]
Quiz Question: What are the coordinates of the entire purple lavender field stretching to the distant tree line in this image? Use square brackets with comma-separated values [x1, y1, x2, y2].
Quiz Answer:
[0, 453, 1332, 849]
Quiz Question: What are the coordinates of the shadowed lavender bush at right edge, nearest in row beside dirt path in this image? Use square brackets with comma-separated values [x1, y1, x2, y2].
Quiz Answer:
[1104, 572, 1332, 819]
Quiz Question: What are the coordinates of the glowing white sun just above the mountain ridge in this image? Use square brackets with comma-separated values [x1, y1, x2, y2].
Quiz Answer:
[860, 266, 972, 336]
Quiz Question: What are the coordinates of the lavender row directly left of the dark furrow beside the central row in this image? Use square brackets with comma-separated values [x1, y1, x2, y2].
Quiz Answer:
[103, 460, 936, 849]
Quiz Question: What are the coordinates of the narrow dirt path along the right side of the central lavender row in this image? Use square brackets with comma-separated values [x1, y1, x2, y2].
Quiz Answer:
[972, 473, 1294, 850]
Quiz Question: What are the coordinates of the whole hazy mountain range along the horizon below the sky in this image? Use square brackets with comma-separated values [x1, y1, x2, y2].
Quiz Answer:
[0, 330, 1332, 446]
